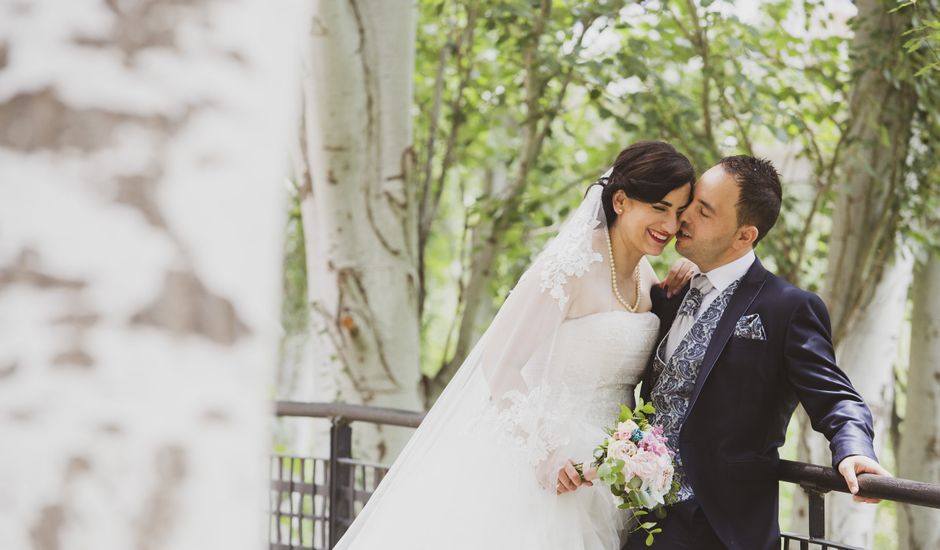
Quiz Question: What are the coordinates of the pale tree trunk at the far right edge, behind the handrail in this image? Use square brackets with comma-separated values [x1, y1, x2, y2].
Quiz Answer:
[898, 254, 940, 550]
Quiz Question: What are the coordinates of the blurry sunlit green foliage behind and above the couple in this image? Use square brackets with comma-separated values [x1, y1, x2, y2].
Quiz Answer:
[415, 0, 940, 382]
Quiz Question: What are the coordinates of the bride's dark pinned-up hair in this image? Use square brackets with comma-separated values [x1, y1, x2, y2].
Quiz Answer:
[597, 141, 695, 227]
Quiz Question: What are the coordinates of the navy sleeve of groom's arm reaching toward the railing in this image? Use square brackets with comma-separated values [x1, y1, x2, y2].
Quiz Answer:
[784, 292, 878, 469]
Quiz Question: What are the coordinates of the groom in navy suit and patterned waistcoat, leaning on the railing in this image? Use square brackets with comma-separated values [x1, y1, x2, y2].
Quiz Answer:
[624, 156, 890, 550]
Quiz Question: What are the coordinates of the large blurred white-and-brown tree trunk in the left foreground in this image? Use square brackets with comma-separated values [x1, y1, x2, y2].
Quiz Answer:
[0, 0, 304, 550]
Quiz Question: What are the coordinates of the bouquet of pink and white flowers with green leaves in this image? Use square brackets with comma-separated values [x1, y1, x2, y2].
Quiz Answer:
[575, 399, 679, 546]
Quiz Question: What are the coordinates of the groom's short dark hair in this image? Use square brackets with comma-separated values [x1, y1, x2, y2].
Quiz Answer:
[719, 155, 783, 245]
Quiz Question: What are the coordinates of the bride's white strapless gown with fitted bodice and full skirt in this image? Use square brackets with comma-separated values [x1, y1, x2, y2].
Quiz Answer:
[337, 312, 659, 550]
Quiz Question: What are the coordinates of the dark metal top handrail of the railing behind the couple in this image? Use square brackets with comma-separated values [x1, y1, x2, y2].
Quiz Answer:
[275, 401, 940, 508]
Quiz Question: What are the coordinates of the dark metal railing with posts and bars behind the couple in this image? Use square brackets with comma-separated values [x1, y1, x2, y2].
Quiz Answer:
[269, 401, 940, 550]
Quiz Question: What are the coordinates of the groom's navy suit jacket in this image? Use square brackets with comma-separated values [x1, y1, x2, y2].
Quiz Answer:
[641, 260, 876, 550]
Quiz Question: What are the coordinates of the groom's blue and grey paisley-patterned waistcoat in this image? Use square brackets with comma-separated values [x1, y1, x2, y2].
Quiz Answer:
[650, 281, 738, 501]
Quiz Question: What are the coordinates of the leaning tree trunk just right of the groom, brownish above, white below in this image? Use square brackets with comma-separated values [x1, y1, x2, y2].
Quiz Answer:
[793, 0, 917, 544]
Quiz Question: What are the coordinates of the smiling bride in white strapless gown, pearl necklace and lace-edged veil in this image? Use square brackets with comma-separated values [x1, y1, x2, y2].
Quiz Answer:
[336, 141, 694, 550]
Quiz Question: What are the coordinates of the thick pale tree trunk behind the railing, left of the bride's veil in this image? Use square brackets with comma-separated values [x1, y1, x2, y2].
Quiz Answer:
[301, 0, 422, 461]
